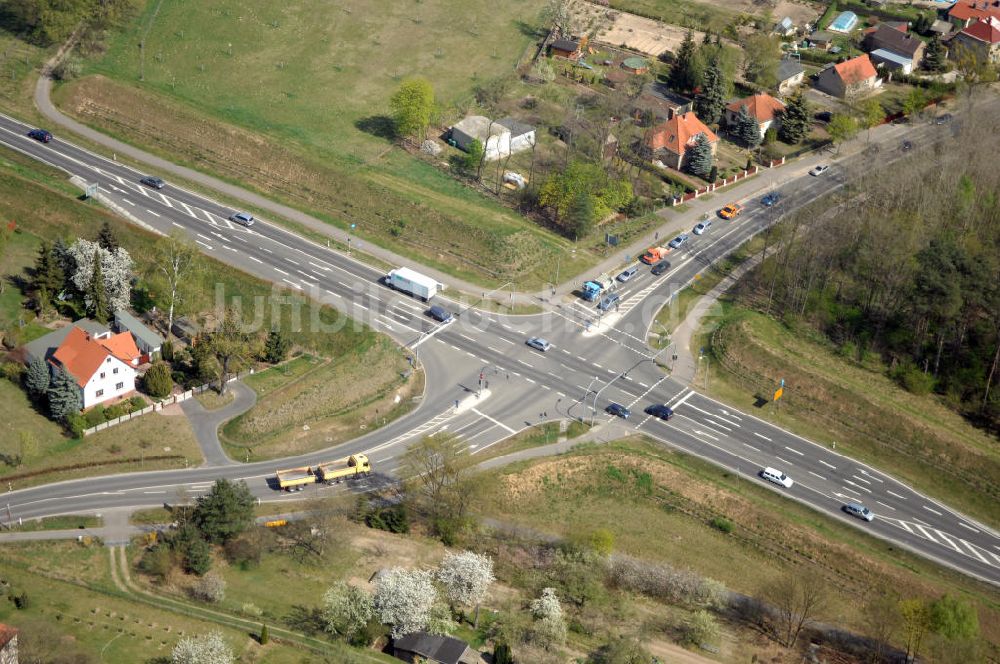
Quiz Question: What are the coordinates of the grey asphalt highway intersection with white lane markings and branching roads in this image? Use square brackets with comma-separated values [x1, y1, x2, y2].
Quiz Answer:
[0, 106, 1000, 584]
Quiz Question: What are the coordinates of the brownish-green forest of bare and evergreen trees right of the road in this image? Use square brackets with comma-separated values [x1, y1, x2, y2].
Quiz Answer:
[748, 106, 1000, 433]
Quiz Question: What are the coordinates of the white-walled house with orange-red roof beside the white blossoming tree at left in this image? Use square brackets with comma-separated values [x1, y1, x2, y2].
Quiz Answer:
[48, 325, 140, 408]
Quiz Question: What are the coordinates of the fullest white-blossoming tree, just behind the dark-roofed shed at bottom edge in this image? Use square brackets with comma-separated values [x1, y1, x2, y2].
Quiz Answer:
[373, 567, 437, 639]
